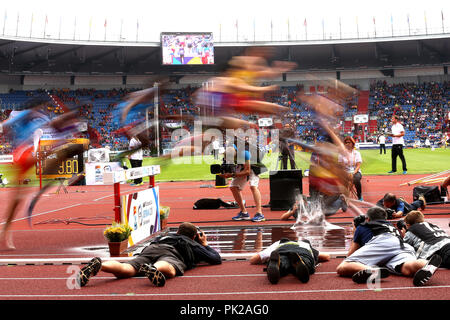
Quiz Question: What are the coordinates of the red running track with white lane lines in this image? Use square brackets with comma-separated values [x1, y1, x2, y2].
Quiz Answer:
[0, 175, 450, 300]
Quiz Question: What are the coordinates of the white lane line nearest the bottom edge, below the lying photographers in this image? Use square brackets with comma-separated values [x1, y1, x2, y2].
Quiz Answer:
[0, 285, 450, 298]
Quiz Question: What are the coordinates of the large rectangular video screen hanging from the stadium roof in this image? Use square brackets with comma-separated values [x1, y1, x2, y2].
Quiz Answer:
[161, 32, 214, 65]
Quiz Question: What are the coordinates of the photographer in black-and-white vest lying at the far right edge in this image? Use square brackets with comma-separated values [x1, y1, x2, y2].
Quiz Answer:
[397, 210, 450, 269]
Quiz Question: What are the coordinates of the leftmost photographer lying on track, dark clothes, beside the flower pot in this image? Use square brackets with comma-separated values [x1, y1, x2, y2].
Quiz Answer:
[78, 222, 222, 287]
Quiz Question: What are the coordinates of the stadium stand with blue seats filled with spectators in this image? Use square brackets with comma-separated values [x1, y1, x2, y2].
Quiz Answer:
[0, 81, 450, 154]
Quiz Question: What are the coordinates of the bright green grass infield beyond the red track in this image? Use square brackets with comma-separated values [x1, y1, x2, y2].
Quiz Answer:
[0, 148, 450, 185]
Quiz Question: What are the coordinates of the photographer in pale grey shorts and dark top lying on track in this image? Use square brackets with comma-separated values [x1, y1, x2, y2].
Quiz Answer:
[336, 207, 442, 286]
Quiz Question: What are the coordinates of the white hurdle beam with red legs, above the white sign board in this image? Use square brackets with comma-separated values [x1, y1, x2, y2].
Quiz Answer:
[103, 165, 161, 223]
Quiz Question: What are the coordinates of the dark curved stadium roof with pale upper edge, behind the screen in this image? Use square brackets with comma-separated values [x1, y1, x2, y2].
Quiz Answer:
[0, 34, 450, 75]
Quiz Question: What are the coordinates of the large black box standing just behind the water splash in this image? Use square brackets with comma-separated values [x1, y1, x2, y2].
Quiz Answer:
[269, 170, 303, 211]
